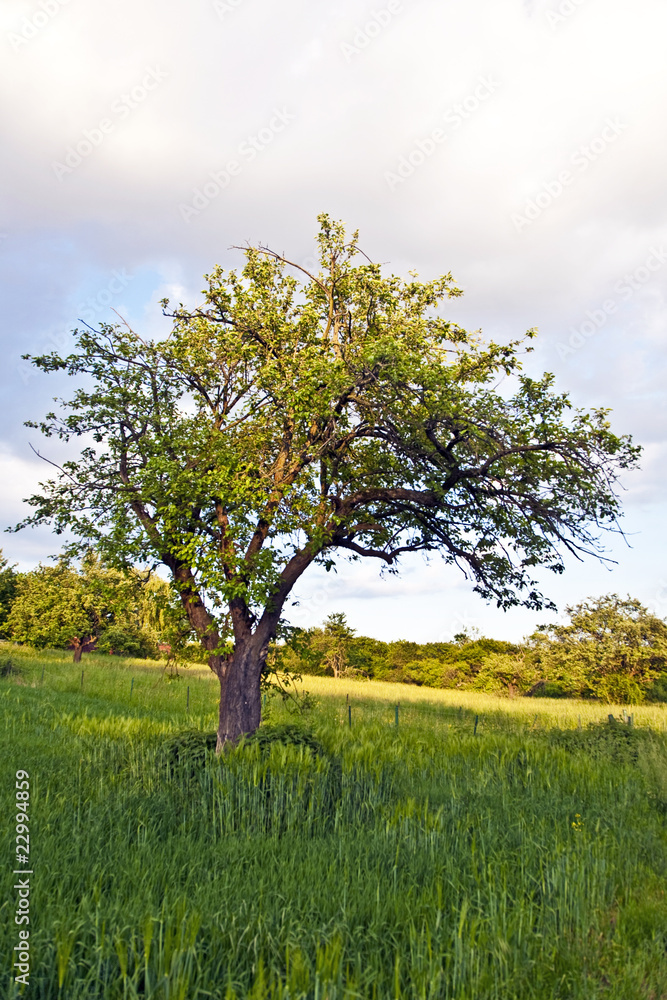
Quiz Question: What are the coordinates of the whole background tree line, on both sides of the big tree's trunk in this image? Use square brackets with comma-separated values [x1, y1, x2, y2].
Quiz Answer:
[0, 551, 667, 704]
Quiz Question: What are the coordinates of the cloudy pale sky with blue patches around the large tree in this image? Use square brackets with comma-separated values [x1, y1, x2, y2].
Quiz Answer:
[0, 0, 667, 641]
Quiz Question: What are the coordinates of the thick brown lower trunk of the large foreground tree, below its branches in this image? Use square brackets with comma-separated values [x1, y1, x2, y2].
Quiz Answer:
[214, 640, 266, 753]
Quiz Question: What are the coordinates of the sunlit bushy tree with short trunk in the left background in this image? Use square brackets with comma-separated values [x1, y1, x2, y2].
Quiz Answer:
[5, 554, 189, 662]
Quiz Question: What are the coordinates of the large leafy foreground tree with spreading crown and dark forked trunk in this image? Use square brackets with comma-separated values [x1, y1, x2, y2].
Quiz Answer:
[17, 216, 639, 748]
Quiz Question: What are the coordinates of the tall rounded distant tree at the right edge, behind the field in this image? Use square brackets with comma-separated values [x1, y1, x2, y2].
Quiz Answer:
[528, 594, 667, 703]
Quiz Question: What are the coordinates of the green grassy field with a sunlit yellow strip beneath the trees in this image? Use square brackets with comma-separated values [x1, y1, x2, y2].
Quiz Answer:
[0, 644, 667, 1000]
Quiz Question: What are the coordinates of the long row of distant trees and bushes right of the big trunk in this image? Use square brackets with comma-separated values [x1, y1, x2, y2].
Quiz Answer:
[277, 594, 667, 704]
